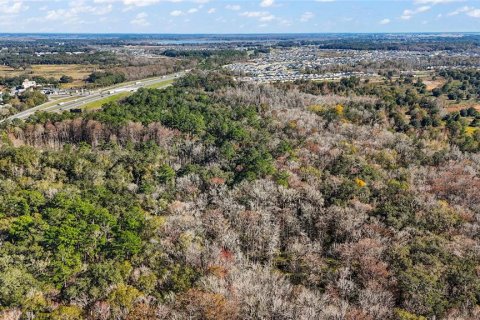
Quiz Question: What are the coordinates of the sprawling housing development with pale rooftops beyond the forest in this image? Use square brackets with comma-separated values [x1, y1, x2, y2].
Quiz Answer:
[224, 46, 480, 82]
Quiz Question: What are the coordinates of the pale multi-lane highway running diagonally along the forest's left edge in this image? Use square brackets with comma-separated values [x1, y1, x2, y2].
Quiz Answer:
[0, 72, 185, 123]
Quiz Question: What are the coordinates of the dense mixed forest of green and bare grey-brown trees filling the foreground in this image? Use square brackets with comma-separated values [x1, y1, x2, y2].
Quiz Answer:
[0, 72, 480, 320]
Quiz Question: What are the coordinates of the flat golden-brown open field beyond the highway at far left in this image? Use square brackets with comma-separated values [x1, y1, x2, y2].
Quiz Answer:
[0, 64, 99, 87]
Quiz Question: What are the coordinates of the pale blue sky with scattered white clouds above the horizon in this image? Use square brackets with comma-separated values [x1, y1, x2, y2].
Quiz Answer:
[0, 0, 480, 33]
